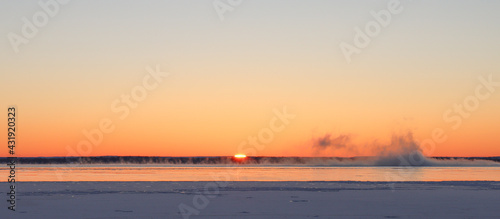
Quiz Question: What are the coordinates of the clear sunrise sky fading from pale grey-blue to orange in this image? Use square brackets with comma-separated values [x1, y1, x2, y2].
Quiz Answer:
[0, 0, 500, 156]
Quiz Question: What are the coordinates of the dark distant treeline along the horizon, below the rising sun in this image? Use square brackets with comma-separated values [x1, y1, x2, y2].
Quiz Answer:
[0, 156, 500, 165]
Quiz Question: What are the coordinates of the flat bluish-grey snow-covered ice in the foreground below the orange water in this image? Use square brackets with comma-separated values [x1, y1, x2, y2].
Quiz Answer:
[0, 182, 500, 218]
